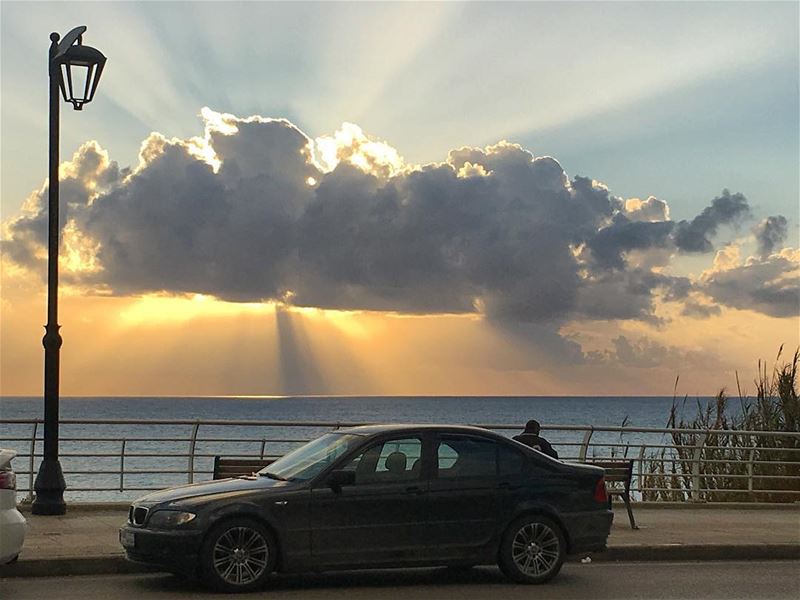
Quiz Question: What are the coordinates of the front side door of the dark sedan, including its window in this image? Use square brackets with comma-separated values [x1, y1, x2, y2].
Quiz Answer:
[311, 434, 429, 566]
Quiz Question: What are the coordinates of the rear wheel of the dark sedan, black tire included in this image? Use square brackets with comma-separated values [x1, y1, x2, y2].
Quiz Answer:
[498, 515, 567, 584]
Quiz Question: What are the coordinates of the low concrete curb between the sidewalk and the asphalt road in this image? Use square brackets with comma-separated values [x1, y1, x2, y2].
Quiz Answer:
[0, 544, 800, 579]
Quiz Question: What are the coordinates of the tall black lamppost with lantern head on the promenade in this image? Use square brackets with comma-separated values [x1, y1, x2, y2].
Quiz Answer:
[32, 26, 106, 515]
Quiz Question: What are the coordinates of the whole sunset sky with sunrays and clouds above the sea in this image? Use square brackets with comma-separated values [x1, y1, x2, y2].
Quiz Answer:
[0, 2, 800, 395]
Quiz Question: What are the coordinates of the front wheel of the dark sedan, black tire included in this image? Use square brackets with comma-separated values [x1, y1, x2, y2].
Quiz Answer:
[200, 517, 278, 592]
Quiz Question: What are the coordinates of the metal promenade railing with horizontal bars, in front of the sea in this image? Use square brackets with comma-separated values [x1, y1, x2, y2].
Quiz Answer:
[0, 419, 800, 501]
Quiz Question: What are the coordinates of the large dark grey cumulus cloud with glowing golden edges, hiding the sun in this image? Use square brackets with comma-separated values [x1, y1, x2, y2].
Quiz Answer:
[2, 109, 784, 331]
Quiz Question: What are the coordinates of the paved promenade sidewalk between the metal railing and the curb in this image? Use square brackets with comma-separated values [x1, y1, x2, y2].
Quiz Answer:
[0, 504, 800, 578]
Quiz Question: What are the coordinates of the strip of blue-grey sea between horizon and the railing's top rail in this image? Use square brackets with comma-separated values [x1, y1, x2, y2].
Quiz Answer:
[0, 395, 712, 427]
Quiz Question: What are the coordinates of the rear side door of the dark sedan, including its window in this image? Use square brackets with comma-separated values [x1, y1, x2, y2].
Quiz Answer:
[427, 433, 499, 560]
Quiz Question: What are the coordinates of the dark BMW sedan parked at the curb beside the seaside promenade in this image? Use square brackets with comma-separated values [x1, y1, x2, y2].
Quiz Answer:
[120, 425, 612, 591]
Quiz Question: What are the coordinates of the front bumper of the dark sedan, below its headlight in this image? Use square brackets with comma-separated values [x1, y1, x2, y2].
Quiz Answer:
[119, 525, 203, 574]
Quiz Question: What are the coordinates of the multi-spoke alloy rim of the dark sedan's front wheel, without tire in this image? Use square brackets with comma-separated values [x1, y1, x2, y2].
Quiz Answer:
[212, 527, 269, 585]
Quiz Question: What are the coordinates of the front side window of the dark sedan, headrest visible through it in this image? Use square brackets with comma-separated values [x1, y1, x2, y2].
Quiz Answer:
[343, 438, 422, 485]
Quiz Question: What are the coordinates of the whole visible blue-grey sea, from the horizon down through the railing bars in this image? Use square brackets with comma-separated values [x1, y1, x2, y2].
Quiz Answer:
[0, 396, 712, 501]
